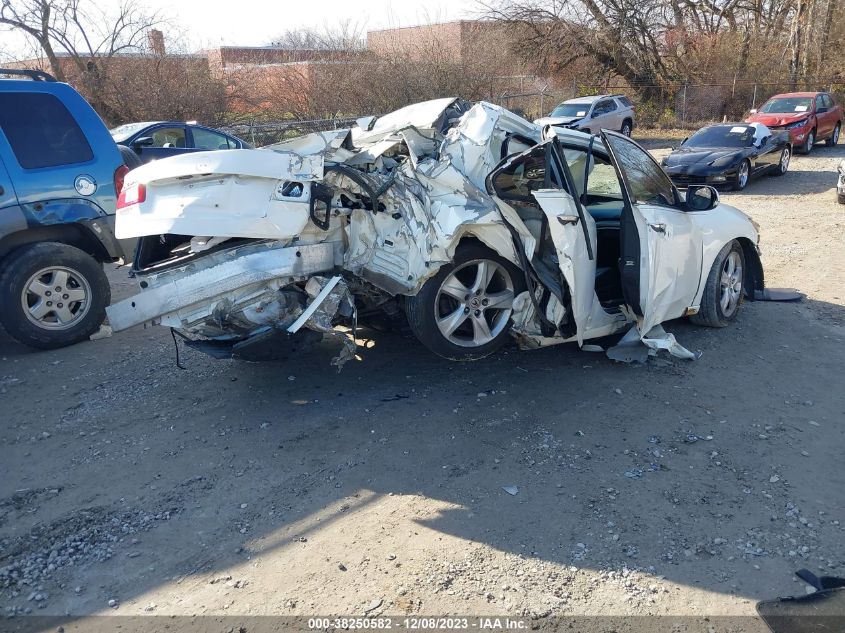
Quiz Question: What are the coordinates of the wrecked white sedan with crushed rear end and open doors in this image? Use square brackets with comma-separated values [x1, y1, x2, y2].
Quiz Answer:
[108, 99, 763, 361]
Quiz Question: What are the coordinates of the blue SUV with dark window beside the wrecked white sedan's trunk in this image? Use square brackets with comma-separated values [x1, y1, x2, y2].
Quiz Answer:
[0, 68, 131, 349]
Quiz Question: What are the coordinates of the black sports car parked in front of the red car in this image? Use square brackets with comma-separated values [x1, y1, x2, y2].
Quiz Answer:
[661, 123, 792, 190]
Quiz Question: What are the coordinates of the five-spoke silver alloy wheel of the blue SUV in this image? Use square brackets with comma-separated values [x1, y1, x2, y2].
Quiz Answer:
[21, 266, 91, 330]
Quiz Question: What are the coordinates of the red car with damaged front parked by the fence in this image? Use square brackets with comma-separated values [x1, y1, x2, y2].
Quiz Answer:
[745, 92, 842, 154]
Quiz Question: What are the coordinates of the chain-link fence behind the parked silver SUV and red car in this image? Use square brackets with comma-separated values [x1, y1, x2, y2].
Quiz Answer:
[496, 80, 845, 129]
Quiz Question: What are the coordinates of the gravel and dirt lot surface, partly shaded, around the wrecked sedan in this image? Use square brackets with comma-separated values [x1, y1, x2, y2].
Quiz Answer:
[0, 146, 845, 630]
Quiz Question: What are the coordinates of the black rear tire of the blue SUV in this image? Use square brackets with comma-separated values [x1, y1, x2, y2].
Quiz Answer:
[0, 242, 111, 349]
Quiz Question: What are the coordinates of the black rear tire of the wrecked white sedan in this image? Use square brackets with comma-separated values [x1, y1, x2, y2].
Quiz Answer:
[405, 242, 525, 361]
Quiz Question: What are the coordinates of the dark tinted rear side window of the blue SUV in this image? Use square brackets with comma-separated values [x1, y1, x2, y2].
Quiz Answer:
[0, 92, 94, 169]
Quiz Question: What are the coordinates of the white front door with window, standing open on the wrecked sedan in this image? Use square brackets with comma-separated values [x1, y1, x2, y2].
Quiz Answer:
[601, 130, 702, 336]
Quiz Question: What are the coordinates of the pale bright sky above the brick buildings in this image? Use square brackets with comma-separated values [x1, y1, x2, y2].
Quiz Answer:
[0, 0, 479, 52]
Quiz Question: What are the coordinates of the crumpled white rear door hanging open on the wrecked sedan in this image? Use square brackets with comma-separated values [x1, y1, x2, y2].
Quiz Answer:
[489, 137, 596, 342]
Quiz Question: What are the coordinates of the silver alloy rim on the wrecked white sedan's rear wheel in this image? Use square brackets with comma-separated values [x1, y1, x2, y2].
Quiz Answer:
[434, 259, 514, 347]
